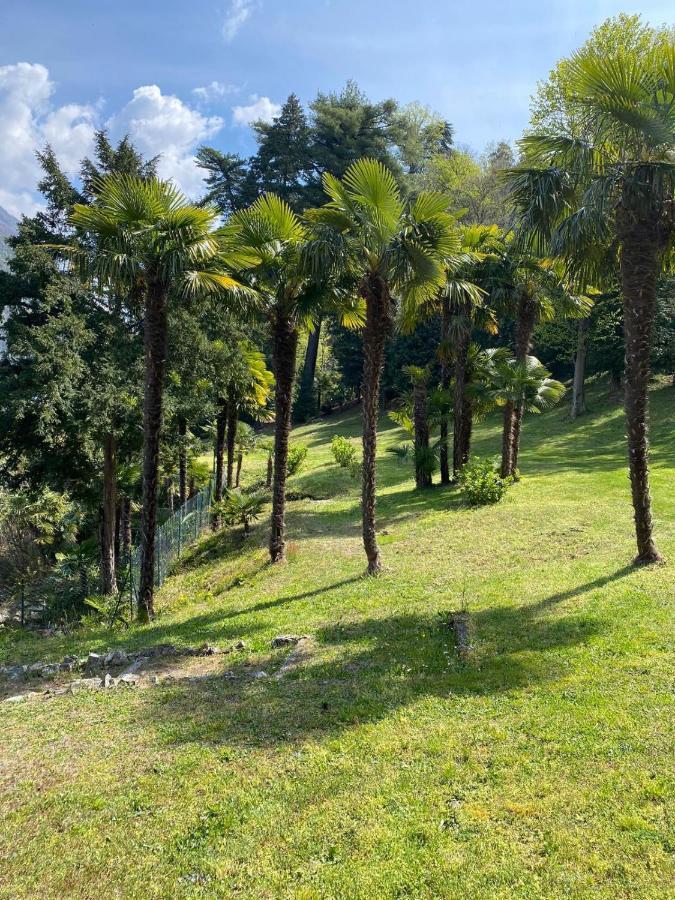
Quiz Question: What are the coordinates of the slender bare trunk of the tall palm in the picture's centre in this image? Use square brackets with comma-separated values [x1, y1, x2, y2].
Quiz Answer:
[361, 276, 390, 575]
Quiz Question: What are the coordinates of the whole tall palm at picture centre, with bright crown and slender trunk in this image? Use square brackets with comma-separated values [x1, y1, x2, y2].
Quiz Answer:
[307, 159, 456, 574]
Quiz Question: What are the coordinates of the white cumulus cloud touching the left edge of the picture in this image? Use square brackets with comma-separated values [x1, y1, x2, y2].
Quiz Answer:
[0, 62, 96, 216]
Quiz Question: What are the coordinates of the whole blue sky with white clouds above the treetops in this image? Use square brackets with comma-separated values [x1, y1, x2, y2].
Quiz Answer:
[0, 0, 675, 216]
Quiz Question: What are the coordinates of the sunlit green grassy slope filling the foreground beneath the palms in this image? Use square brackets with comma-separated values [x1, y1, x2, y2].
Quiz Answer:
[0, 387, 675, 898]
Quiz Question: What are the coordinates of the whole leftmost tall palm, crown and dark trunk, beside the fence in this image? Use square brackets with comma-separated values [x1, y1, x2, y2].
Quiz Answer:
[71, 175, 251, 621]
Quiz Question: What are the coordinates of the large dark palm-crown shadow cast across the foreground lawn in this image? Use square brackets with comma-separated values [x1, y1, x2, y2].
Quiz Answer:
[139, 607, 600, 746]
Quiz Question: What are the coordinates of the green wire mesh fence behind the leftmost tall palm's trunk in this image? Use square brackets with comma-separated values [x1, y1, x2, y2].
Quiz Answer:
[128, 479, 215, 618]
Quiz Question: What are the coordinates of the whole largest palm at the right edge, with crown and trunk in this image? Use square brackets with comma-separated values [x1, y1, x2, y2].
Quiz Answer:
[511, 40, 675, 563]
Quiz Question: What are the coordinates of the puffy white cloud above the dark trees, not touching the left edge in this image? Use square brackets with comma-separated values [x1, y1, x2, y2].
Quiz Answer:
[107, 84, 223, 197]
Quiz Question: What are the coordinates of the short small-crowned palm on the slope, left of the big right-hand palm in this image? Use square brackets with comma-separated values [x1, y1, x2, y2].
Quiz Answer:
[488, 348, 565, 468]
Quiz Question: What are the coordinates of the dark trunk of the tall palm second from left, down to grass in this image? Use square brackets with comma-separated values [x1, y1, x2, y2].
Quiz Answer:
[270, 310, 298, 562]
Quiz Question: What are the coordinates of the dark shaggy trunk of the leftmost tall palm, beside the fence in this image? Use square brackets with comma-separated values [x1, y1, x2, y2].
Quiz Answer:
[138, 282, 167, 622]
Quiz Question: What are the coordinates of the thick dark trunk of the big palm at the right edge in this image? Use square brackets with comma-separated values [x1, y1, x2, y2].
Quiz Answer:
[617, 204, 663, 563]
